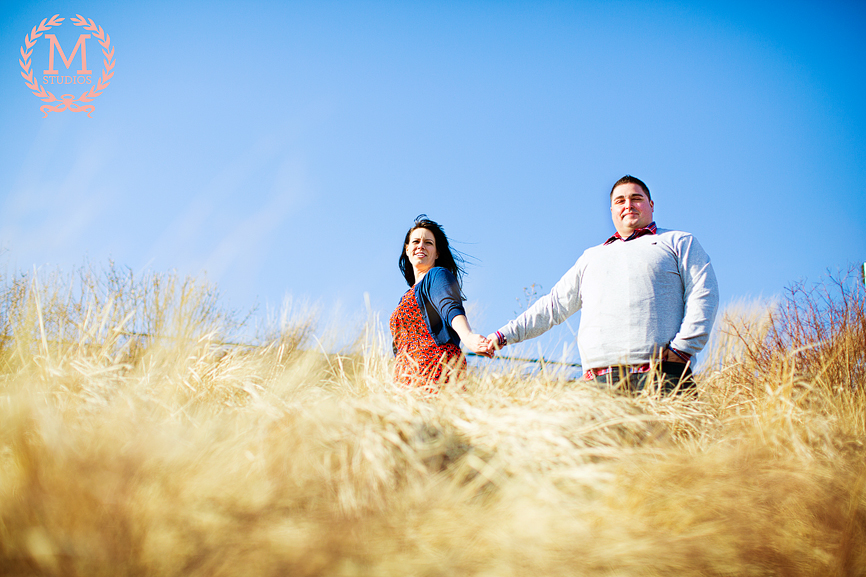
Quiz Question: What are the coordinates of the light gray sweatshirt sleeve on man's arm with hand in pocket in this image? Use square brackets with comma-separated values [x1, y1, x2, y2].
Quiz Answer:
[671, 235, 719, 356]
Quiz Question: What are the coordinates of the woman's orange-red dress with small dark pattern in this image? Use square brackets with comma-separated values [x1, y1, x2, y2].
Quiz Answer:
[390, 288, 466, 393]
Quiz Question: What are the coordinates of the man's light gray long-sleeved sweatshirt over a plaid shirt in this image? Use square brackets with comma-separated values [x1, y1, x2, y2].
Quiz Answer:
[500, 229, 719, 369]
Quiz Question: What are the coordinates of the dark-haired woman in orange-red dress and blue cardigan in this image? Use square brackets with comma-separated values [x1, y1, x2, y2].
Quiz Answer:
[390, 214, 490, 393]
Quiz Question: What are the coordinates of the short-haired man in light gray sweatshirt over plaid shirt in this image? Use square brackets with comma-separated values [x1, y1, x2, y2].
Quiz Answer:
[488, 175, 719, 391]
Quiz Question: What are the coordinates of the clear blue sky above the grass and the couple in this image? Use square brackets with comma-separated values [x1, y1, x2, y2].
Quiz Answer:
[0, 0, 866, 358]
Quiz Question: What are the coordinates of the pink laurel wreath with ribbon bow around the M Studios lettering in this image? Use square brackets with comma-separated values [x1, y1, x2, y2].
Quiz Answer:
[18, 14, 114, 118]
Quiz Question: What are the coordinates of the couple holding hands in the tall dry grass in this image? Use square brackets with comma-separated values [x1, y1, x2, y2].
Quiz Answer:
[390, 175, 719, 393]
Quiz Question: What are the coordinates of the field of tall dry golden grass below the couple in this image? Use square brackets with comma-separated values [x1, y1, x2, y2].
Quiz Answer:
[0, 265, 866, 577]
